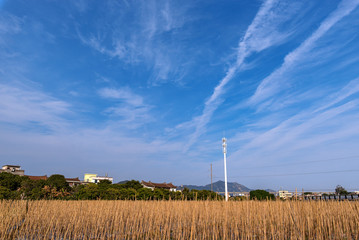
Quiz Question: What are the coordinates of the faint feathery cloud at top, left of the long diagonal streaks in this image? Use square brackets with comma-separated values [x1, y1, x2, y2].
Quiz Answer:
[77, 0, 191, 85]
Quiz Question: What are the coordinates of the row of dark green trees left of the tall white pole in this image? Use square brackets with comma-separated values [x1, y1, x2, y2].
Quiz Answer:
[0, 173, 223, 200]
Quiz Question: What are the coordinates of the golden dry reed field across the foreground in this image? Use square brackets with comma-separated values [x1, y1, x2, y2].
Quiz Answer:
[0, 200, 359, 239]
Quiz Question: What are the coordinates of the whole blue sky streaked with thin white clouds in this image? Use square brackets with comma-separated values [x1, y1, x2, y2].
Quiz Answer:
[0, 0, 359, 190]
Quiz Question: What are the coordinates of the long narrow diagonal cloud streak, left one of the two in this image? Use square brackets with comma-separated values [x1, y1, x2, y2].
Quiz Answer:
[185, 0, 304, 151]
